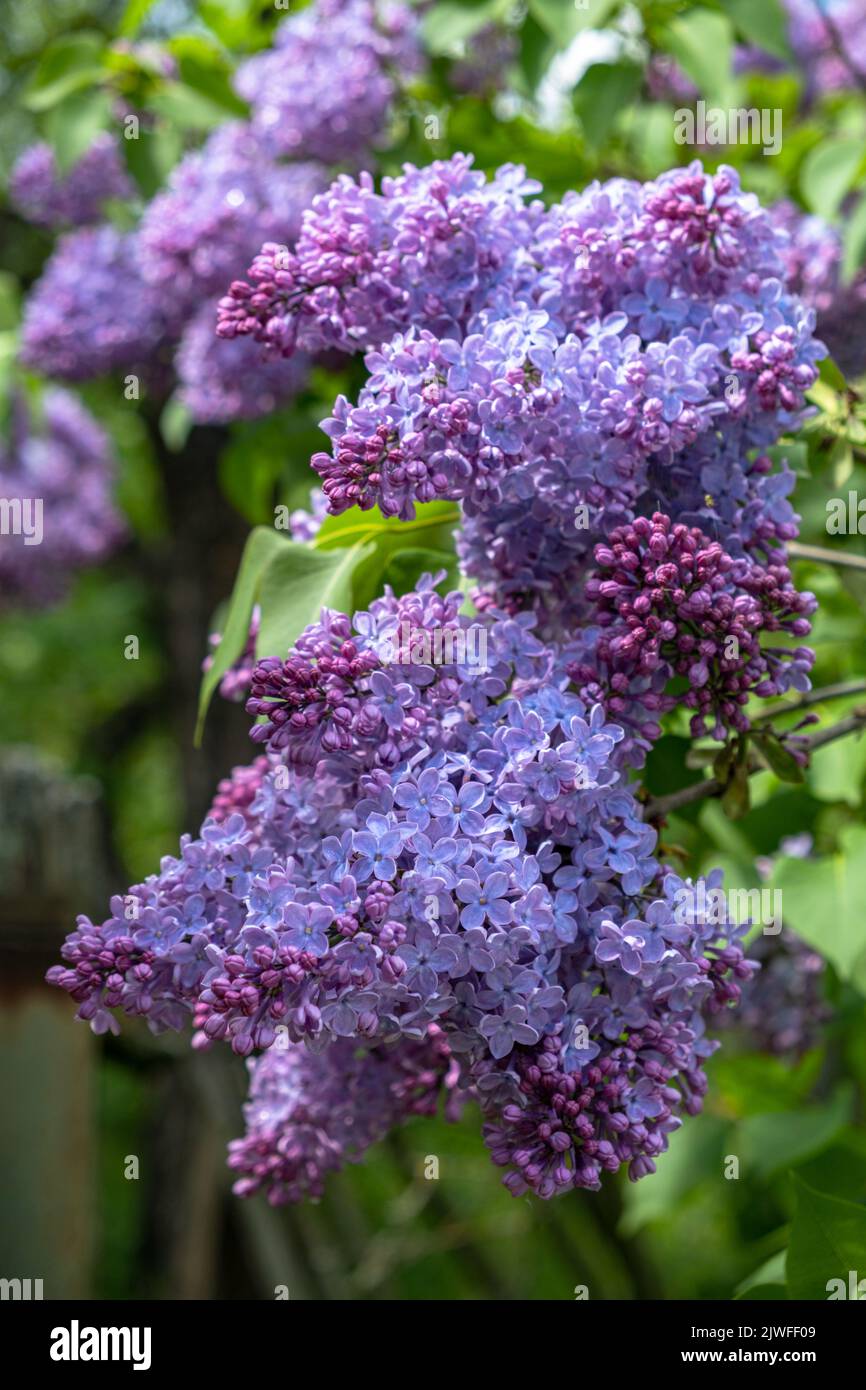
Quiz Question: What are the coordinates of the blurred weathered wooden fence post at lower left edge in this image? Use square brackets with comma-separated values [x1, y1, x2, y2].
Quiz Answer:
[0, 748, 108, 1298]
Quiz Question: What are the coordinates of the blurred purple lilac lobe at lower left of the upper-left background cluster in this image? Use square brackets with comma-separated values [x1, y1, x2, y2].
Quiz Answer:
[21, 224, 175, 381]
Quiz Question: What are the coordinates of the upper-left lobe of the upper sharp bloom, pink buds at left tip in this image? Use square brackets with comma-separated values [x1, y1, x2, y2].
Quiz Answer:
[218, 154, 541, 354]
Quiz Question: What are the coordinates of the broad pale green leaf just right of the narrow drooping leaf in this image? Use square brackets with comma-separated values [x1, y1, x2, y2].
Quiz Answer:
[256, 541, 371, 656]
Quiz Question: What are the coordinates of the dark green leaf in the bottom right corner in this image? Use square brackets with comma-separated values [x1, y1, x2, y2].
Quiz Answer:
[787, 1175, 866, 1298]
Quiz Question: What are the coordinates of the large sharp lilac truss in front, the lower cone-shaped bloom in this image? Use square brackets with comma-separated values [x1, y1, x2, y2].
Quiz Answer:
[49, 577, 752, 1200]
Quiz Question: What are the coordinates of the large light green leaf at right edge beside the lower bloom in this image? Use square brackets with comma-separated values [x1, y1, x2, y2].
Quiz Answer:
[770, 826, 866, 994]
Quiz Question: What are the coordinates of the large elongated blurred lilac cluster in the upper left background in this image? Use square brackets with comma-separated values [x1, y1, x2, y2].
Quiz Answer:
[11, 0, 420, 424]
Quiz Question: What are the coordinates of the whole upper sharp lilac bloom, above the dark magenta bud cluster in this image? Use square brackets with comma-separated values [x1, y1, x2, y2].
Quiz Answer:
[218, 156, 824, 635]
